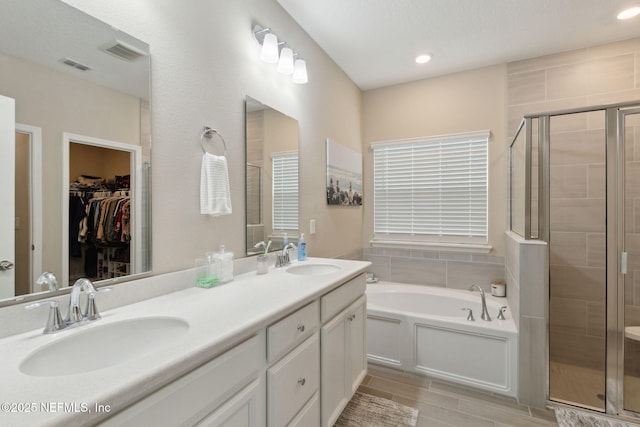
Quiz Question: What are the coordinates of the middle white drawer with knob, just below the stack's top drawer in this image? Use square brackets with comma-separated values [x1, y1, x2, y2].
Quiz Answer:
[267, 333, 320, 427]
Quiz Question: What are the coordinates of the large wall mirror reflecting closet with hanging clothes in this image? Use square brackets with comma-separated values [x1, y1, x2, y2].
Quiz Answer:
[0, 0, 151, 306]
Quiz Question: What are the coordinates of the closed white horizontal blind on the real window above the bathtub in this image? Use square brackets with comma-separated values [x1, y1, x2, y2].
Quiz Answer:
[372, 132, 489, 242]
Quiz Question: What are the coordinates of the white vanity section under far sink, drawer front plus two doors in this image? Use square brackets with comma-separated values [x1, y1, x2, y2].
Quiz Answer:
[320, 276, 367, 427]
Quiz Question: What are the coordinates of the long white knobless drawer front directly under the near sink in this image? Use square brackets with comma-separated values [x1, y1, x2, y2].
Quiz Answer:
[103, 334, 264, 426]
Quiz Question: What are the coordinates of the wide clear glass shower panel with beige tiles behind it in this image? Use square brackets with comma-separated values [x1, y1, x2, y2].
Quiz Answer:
[548, 110, 608, 412]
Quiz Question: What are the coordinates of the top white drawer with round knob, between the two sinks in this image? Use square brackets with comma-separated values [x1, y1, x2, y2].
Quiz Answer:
[267, 300, 320, 362]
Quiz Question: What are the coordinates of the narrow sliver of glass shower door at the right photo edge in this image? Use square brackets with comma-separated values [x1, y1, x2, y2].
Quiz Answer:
[619, 109, 640, 412]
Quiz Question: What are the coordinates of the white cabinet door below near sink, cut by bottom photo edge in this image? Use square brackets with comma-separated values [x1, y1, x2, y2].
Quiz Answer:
[196, 378, 265, 427]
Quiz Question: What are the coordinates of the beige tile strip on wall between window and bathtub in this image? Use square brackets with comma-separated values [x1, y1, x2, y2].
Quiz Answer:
[362, 248, 509, 294]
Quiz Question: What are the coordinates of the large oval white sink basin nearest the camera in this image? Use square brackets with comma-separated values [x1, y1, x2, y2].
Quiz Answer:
[20, 317, 189, 377]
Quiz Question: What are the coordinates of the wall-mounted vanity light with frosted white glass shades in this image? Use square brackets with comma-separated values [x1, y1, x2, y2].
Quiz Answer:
[253, 25, 309, 84]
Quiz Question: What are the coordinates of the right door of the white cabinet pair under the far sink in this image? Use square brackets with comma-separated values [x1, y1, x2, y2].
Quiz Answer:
[347, 300, 367, 396]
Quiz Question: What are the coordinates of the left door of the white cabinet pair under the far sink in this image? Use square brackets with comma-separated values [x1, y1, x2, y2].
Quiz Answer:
[320, 312, 349, 426]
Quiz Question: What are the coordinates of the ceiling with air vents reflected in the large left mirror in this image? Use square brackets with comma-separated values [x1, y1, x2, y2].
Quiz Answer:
[0, 0, 149, 99]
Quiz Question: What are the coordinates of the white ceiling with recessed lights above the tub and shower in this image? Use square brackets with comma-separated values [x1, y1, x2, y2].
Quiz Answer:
[276, 0, 640, 90]
